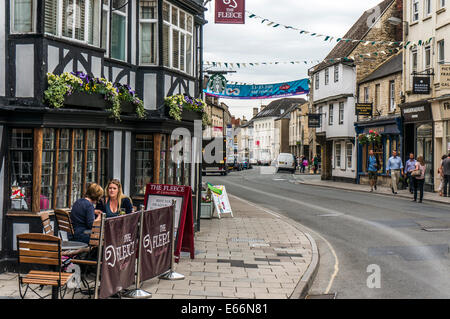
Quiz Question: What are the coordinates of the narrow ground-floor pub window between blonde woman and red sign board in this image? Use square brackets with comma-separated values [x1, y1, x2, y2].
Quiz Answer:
[134, 134, 153, 195]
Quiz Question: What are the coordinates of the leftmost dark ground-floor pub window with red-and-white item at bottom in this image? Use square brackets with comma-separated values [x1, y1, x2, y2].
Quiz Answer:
[9, 129, 33, 211]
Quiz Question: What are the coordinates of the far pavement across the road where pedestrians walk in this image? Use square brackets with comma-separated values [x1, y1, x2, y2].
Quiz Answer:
[293, 172, 450, 204]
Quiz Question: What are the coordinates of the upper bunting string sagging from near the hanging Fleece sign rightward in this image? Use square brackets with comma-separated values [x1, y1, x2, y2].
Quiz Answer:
[245, 10, 433, 49]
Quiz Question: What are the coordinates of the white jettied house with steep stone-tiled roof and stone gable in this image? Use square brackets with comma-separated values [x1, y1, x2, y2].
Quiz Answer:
[309, 0, 402, 182]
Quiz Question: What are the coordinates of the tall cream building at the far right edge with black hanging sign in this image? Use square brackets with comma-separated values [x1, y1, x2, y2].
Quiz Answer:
[400, 0, 450, 191]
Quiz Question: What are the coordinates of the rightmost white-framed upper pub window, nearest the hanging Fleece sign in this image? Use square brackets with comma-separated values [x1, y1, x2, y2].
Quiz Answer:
[162, 2, 193, 75]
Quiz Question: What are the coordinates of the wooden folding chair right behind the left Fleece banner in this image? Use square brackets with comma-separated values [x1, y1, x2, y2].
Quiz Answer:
[71, 214, 106, 298]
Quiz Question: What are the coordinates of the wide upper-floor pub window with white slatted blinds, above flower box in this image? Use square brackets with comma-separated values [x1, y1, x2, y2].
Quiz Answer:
[44, 0, 101, 46]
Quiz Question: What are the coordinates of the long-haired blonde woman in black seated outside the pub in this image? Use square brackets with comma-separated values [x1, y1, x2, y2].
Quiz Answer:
[96, 179, 133, 218]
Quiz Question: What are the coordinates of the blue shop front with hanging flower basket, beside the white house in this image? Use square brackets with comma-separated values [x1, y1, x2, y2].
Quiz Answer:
[355, 116, 403, 186]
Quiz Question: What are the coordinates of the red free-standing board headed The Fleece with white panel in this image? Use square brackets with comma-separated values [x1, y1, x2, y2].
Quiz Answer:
[144, 184, 195, 262]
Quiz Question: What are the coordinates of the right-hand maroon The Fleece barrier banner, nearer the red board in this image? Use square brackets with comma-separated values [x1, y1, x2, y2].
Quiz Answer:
[139, 206, 174, 281]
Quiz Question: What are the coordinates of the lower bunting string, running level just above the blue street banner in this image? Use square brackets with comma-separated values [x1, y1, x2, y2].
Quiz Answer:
[203, 48, 402, 68]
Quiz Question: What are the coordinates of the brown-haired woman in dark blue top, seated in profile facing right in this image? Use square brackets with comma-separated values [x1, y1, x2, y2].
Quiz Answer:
[69, 183, 103, 244]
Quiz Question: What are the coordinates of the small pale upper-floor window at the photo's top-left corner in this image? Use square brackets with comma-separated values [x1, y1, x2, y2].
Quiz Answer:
[11, 0, 36, 33]
